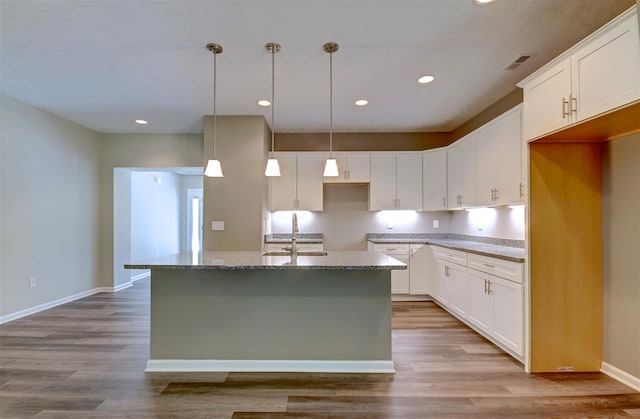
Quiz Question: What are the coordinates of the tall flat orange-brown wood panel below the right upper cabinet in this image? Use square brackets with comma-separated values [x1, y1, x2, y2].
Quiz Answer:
[529, 143, 603, 372]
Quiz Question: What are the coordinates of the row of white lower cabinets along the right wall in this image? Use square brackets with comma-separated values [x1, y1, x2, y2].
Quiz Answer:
[431, 246, 524, 359]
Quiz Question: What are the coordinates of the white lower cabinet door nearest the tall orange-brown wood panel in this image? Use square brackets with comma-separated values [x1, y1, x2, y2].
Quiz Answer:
[490, 277, 524, 355]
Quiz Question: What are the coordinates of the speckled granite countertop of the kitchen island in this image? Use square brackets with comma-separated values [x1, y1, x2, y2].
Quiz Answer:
[124, 251, 407, 271]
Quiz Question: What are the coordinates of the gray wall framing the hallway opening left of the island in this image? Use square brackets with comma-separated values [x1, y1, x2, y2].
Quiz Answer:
[100, 134, 202, 287]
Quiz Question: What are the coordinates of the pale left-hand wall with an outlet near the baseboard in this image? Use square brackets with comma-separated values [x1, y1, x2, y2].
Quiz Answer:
[0, 95, 101, 316]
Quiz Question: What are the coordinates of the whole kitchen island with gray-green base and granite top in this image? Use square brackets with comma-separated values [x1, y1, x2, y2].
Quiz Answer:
[125, 252, 406, 373]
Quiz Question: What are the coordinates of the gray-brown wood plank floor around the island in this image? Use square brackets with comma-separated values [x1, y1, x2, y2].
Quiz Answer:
[0, 280, 640, 418]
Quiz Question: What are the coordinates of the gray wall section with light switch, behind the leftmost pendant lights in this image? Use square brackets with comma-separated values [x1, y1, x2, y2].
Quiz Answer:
[203, 116, 270, 250]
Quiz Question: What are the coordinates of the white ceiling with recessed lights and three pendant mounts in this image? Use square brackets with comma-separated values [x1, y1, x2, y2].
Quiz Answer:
[0, 0, 635, 133]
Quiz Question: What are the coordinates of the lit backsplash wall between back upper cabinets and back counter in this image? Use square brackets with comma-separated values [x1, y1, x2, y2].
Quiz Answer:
[271, 184, 450, 250]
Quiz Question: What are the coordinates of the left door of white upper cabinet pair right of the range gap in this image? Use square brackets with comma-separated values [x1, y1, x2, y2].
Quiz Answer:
[369, 153, 396, 211]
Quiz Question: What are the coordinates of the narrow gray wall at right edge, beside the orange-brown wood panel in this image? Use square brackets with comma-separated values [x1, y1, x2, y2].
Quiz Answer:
[602, 134, 640, 377]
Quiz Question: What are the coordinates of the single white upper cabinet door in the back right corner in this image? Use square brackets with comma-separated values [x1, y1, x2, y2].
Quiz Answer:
[422, 148, 447, 211]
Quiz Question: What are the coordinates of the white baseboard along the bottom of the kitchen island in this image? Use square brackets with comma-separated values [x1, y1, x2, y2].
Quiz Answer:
[145, 359, 396, 374]
